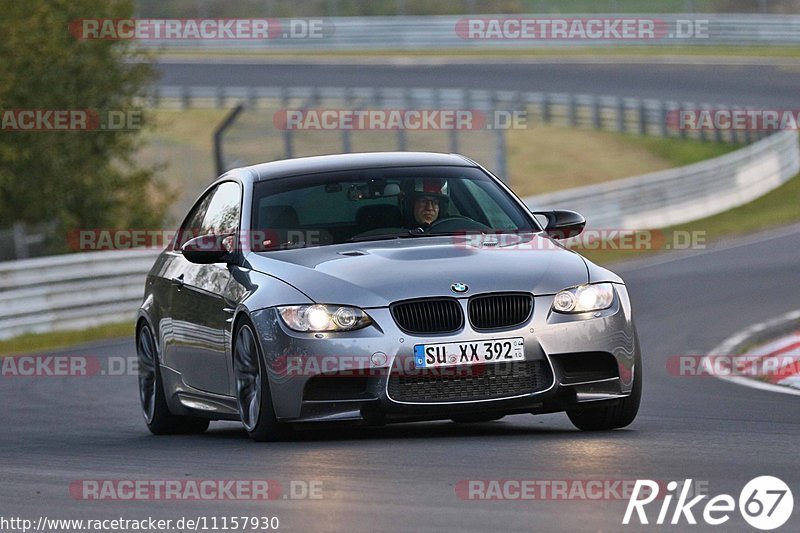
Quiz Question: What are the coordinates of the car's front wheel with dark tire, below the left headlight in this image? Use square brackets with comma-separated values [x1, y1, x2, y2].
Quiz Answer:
[232, 319, 290, 442]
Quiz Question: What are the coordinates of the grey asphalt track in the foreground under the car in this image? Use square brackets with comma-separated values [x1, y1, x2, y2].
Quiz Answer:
[0, 226, 800, 532]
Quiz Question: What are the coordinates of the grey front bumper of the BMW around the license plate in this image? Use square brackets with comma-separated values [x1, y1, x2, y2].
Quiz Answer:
[251, 285, 641, 424]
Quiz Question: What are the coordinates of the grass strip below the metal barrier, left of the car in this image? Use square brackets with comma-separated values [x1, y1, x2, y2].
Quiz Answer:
[0, 322, 133, 357]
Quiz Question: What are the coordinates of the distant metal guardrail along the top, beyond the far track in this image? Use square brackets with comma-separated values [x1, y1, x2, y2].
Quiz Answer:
[141, 13, 800, 51]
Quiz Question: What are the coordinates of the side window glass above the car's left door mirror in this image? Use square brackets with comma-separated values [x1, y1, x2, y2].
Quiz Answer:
[176, 181, 242, 249]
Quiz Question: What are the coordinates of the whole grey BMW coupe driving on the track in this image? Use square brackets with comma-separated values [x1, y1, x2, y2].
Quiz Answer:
[136, 152, 642, 441]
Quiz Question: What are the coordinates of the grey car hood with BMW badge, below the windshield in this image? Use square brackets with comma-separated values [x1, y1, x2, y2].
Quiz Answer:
[247, 234, 588, 308]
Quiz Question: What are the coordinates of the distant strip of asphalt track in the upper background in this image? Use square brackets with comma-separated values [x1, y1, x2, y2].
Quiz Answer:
[158, 57, 800, 108]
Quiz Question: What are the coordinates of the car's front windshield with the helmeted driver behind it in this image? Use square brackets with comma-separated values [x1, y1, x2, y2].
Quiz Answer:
[251, 167, 539, 251]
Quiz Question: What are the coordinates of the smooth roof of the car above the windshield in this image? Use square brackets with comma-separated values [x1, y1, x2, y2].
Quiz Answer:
[238, 152, 478, 181]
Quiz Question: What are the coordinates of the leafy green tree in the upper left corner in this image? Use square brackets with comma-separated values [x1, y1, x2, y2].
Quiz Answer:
[0, 0, 174, 252]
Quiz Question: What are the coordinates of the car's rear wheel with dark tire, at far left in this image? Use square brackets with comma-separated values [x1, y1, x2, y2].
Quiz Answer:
[136, 324, 210, 435]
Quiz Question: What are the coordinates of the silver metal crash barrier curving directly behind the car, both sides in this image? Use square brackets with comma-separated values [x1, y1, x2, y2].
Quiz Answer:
[0, 135, 800, 339]
